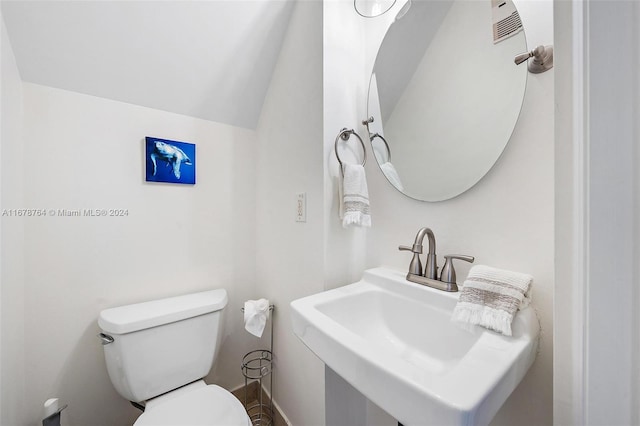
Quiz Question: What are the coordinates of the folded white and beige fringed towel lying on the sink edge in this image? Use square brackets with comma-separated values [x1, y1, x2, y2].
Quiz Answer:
[452, 265, 533, 336]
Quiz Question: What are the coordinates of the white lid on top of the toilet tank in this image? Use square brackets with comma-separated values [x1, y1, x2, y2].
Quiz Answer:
[98, 289, 228, 334]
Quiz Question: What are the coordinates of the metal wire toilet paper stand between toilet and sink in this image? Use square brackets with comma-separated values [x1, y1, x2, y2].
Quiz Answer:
[242, 305, 275, 426]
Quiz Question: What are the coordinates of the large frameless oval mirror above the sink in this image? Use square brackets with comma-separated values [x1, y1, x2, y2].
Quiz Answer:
[368, 0, 527, 201]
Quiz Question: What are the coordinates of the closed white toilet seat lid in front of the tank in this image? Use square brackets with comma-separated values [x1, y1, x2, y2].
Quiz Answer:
[134, 381, 251, 426]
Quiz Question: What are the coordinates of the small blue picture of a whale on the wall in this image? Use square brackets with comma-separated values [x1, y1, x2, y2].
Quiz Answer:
[145, 136, 196, 185]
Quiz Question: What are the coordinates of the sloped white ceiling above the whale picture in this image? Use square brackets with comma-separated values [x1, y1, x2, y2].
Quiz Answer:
[2, 0, 293, 129]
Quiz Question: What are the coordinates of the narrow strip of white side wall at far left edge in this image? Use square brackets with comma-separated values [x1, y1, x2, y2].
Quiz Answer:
[0, 9, 25, 425]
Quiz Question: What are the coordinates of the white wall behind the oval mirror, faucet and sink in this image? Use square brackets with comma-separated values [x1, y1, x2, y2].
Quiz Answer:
[324, 0, 554, 425]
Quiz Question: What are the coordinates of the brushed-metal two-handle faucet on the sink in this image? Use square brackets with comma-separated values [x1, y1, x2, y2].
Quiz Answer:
[398, 228, 475, 291]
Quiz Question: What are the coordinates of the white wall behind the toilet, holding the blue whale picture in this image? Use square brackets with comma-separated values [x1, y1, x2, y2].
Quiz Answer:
[24, 83, 256, 426]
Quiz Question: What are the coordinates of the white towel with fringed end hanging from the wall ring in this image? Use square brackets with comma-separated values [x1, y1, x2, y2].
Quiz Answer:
[339, 164, 371, 228]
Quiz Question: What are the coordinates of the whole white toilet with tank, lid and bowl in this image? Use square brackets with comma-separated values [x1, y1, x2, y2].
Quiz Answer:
[98, 289, 251, 426]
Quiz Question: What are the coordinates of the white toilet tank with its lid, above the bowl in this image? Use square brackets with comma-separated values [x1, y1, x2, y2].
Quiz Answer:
[98, 289, 227, 402]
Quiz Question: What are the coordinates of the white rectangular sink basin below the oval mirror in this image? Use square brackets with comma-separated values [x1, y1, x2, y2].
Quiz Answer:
[291, 268, 540, 426]
